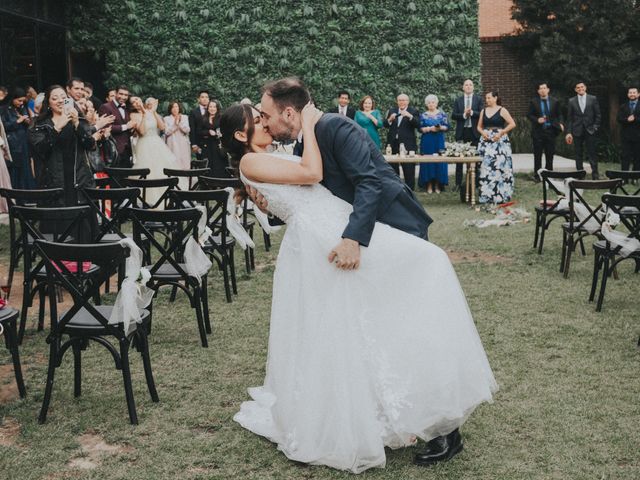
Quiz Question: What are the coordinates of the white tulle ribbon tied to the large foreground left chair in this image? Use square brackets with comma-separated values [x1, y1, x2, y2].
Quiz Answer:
[109, 238, 155, 335]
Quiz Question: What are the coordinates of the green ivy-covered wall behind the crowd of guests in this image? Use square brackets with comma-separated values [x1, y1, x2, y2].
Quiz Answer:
[69, 0, 480, 110]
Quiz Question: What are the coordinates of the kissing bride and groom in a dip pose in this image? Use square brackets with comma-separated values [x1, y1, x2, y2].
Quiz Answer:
[220, 77, 497, 473]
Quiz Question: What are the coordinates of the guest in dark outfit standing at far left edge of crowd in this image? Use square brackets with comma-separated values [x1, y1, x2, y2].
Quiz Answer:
[0, 87, 36, 189]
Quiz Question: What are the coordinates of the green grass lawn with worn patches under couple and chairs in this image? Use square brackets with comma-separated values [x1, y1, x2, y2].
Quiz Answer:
[0, 165, 640, 480]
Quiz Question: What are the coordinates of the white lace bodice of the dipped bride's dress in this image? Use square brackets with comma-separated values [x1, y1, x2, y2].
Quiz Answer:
[240, 153, 353, 226]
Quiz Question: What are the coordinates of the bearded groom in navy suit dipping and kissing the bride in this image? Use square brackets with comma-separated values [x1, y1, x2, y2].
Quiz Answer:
[249, 77, 462, 466]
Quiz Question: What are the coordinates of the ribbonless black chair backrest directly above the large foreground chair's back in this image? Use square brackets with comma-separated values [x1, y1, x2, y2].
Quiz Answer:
[82, 187, 140, 242]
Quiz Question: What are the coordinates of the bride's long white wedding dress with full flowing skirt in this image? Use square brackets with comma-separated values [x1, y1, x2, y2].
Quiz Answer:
[234, 155, 497, 473]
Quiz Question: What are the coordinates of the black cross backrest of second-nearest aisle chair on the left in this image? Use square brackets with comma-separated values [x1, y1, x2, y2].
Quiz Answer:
[127, 208, 200, 280]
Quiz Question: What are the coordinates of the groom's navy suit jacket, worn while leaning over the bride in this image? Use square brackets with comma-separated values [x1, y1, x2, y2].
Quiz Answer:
[315, 113, 432, 246]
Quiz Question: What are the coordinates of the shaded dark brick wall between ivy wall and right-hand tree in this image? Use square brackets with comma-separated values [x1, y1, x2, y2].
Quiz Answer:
[480, 37, 535, 117]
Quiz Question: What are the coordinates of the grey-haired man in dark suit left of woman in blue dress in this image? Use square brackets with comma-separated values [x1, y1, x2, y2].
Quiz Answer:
[384, 93, 420, 190]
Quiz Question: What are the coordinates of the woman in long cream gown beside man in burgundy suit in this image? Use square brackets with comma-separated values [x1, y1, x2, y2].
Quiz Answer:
[131, 97, 179, 206]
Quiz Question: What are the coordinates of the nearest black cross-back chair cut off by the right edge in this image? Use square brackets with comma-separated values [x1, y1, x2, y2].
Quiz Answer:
[589, 194, 640, 314]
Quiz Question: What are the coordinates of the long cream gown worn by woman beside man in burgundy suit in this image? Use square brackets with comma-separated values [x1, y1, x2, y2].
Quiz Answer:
[133, 112, 180, 205]
